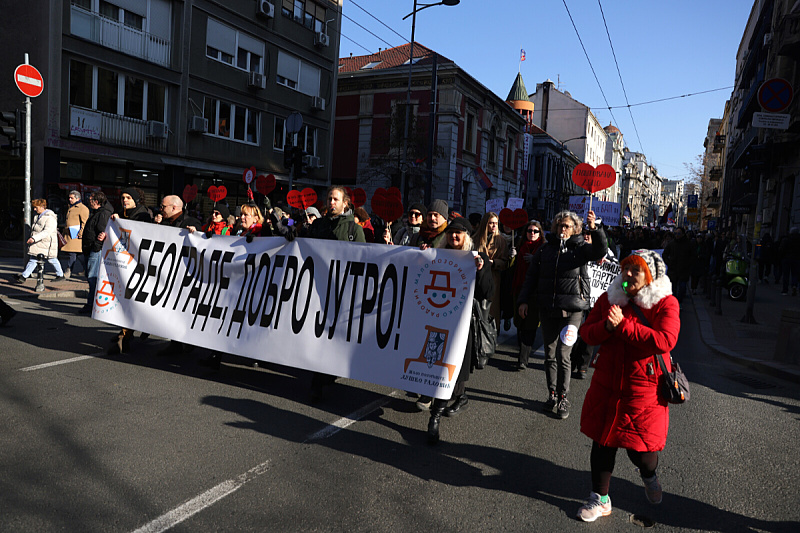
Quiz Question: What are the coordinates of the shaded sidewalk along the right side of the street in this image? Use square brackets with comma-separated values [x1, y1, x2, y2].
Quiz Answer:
[682, 278, 800, 383]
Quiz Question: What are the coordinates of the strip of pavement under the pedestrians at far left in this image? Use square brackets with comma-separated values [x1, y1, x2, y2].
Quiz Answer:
[0, 241, 89, 299]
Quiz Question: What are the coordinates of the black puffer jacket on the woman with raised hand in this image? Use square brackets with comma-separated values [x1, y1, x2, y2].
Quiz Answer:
[517, 230, 608, 312]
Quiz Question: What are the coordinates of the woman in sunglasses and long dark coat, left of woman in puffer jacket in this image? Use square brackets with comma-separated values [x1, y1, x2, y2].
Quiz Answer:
[511, 220, 544, 370]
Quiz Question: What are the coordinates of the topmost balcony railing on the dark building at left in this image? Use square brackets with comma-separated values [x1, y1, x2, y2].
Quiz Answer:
[70, 5, 172, 67]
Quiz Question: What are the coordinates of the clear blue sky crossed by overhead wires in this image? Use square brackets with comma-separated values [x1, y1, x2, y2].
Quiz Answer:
[339, 0, 753, 179]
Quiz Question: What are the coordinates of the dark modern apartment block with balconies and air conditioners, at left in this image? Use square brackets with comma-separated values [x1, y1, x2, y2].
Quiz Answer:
[0, 0, 341, 220]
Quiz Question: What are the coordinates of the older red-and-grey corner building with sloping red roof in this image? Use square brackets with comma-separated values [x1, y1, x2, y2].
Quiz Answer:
[332, 43, 525, 214]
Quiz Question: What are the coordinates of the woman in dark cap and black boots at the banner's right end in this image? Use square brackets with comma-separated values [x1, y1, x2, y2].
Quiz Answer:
[428, 217, 494, 444]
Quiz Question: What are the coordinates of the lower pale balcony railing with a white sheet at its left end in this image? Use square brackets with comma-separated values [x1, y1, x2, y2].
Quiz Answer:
[69, 106, 167, 152]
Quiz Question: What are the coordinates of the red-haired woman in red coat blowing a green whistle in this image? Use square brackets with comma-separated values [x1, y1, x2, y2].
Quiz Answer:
[578, 250, 680, 522]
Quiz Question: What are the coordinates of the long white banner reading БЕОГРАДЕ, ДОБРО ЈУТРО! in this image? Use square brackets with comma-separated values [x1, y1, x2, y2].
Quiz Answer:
[93, 220, 475, 398]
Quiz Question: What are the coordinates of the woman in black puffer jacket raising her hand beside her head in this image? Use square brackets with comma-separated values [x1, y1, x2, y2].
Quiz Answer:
[518, 211, 608, 420]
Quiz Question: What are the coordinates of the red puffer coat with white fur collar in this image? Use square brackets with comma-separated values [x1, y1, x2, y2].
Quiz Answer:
[580, 276, 680, 452]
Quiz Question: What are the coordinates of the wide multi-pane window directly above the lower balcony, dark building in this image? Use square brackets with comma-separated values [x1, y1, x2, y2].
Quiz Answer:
[69, 61, 167, 122]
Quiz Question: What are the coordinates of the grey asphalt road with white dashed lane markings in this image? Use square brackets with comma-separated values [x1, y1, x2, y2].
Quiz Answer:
[0, 300, 800, 533]
